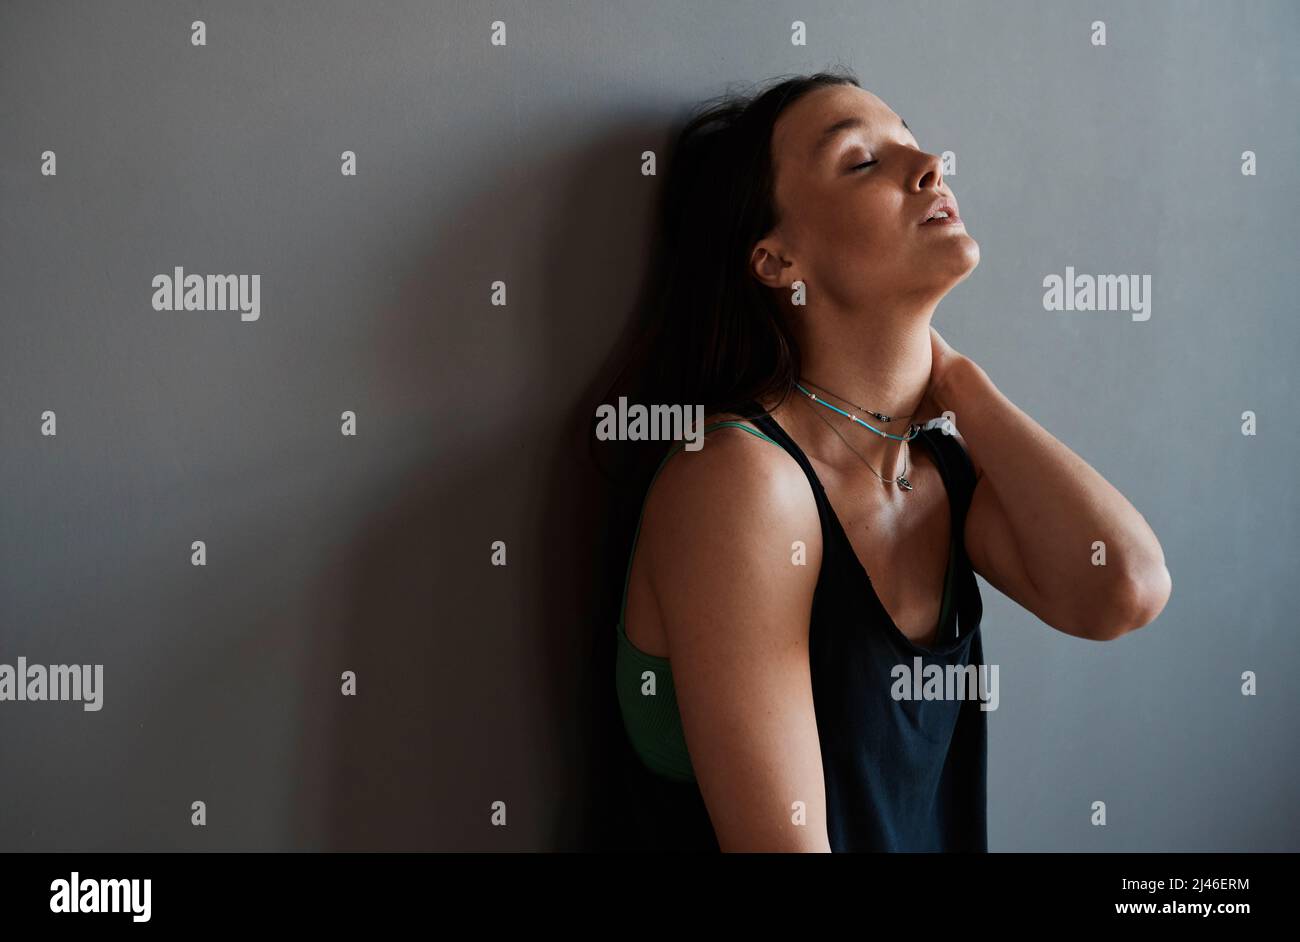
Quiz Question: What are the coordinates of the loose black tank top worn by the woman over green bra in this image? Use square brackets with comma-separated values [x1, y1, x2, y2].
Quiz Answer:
[608, 403, 988, 852]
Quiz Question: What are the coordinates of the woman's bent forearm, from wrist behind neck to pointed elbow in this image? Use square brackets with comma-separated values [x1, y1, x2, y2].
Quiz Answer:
[936, 357, 1169, 621]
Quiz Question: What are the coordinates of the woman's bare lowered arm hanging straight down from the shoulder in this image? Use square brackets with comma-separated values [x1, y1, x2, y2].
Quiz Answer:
[644, 429, 829, 851]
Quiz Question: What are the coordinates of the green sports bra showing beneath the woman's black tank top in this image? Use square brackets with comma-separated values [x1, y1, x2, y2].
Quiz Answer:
[614, 421, 953, 782]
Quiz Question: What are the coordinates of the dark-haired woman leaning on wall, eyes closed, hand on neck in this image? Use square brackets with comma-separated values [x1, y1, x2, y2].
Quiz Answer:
[595, 73, 1171, 851]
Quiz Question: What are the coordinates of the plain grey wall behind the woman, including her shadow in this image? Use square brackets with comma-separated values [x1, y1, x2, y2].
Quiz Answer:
[0, 0, 1300, 851]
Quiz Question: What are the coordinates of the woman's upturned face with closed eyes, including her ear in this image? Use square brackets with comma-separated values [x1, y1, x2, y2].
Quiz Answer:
[751, 86, 979, 311]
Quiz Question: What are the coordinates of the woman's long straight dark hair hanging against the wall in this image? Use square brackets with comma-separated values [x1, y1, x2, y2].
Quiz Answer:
[593, 66, 861, 480]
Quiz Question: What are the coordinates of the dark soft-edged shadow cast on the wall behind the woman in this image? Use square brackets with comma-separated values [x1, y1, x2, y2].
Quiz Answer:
[282, 114, 670, 851]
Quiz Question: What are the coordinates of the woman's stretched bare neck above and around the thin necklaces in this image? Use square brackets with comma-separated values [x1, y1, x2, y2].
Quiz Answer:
[796, 301, 933, 479]
